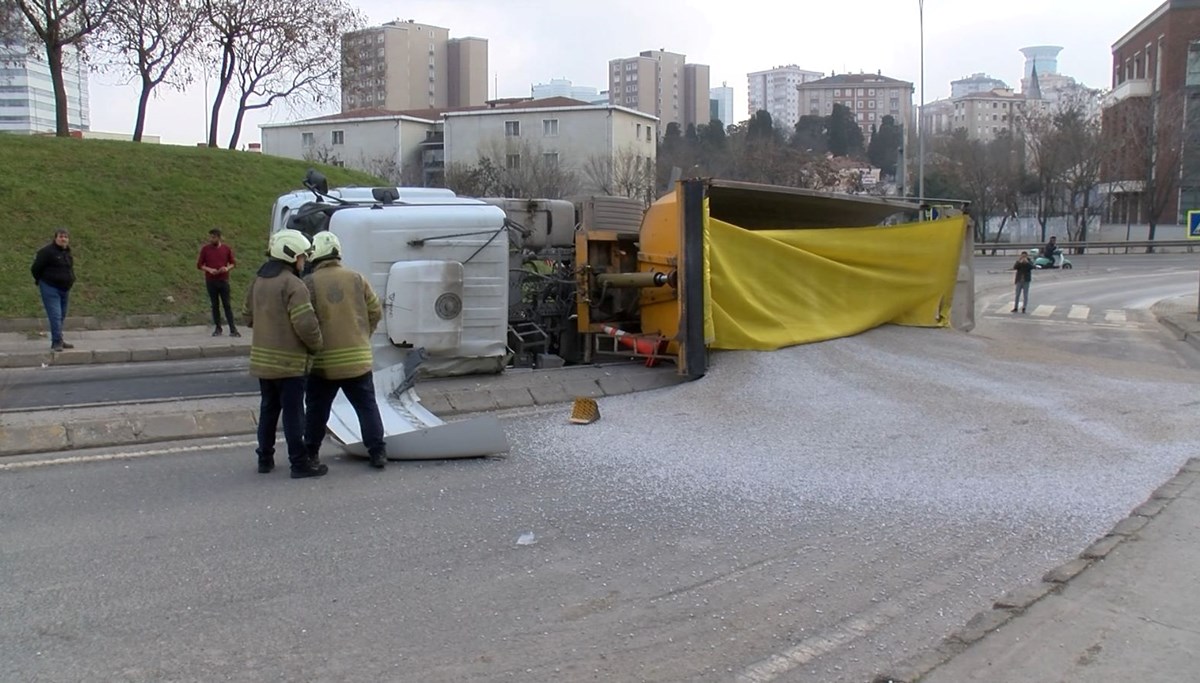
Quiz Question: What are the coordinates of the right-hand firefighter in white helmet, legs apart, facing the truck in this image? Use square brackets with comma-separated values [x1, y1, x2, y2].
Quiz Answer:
[304, 230, 388, 469]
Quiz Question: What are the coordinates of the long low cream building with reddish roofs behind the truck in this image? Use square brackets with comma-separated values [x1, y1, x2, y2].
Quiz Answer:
[259, 97, 659, 192]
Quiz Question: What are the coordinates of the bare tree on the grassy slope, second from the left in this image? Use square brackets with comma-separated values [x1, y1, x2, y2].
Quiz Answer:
[104, 0, 203, 142]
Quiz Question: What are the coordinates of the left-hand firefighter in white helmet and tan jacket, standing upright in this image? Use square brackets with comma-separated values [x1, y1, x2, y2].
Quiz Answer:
[242, 229, 329, 479]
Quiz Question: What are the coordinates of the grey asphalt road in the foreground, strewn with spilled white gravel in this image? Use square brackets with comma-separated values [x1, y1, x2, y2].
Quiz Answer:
[0, 278, 1200, 683]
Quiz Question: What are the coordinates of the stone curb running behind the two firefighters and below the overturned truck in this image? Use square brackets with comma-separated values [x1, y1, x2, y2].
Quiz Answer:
[0, 372, 688, 457]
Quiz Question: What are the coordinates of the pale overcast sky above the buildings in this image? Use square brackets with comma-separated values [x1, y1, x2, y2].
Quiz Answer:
[90, 0, 1162, 145]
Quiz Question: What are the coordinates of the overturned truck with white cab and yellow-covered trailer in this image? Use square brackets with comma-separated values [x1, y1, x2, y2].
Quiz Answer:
[271, 173, 973, 459]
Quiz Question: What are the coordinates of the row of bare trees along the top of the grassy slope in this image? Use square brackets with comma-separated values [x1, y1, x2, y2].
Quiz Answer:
[0, 0, 364, 149]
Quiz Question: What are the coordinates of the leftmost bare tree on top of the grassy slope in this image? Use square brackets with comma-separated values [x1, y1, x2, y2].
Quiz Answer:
[10, 0, 116, 137]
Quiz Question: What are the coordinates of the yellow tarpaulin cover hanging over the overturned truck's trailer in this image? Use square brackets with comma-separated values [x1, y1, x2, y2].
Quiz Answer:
[704, 216, 966, 351]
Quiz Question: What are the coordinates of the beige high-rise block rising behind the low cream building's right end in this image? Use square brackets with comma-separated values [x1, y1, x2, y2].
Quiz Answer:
[608, 50, 709, 130]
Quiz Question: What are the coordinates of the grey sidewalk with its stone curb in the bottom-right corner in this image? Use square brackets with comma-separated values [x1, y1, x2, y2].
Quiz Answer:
[875, 457, 1200, 683]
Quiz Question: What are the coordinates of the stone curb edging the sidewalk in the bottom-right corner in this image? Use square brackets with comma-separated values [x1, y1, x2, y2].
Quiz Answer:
[871, 457, 1200, 683]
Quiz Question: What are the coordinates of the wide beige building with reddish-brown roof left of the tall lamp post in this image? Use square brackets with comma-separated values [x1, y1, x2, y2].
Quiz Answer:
[796, 73, 913, 142]
